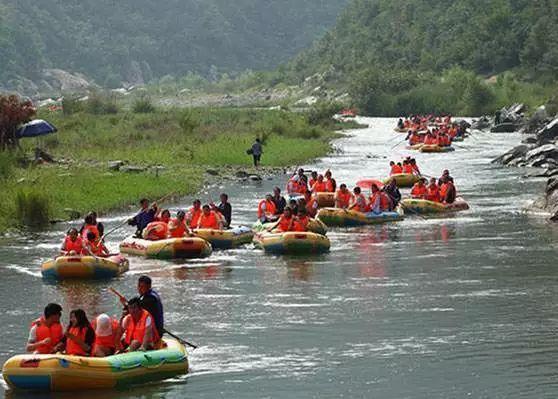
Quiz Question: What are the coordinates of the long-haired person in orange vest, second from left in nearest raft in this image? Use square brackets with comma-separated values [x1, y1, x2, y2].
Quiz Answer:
[62, 309, 95, 356]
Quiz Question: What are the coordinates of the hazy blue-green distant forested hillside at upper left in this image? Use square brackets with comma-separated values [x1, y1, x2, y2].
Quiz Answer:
[0, 0, 346, 86]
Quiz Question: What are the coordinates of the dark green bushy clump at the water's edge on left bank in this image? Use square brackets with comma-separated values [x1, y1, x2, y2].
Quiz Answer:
[15, 189, 50, 227]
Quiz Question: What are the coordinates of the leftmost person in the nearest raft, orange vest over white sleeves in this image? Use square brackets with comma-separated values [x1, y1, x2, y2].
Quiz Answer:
[25, 303, 64, 354]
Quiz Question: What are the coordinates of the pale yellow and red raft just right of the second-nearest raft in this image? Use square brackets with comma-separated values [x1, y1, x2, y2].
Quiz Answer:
[120, 237, 212, 259]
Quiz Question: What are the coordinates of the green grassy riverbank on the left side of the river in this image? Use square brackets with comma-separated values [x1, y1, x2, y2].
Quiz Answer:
[0, 106, 346, 232]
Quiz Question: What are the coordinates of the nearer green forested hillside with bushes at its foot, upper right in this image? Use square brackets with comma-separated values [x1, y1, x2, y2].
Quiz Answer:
[282, 0, 558, 114]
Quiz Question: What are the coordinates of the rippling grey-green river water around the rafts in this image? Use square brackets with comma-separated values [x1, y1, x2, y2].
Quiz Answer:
[0, 118, 558, 398]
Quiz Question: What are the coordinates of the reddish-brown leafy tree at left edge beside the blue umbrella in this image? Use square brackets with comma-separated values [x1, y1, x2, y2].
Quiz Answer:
[0, 95, 37, 151]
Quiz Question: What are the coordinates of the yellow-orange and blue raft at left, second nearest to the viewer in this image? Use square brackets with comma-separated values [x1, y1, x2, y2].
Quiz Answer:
[41, 255, 130, 280]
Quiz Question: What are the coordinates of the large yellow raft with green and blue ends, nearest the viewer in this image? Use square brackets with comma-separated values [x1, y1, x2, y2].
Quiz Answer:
[2, 339, 188, 392]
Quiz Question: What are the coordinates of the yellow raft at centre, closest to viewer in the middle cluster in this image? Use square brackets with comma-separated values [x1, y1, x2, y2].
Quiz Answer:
[254, 231, 330, 255]
